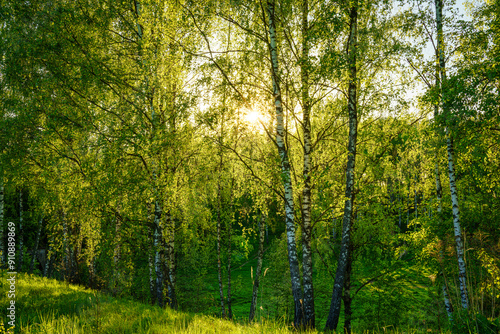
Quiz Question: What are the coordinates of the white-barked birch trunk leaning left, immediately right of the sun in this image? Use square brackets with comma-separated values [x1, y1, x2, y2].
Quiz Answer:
[267, 0, 304, 328]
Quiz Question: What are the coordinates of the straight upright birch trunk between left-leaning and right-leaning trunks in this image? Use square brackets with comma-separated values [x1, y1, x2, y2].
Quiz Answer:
[301, 0, 316, 328]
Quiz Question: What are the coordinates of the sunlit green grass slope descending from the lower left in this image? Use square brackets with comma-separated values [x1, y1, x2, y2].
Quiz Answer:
[0, 270, 450, 334]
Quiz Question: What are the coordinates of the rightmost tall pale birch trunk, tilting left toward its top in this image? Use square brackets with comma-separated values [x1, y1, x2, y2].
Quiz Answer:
[435, 0, 469, 309]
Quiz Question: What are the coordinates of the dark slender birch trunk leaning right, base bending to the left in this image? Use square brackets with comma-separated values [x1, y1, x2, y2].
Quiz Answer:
[326, 0, 358, 331]
